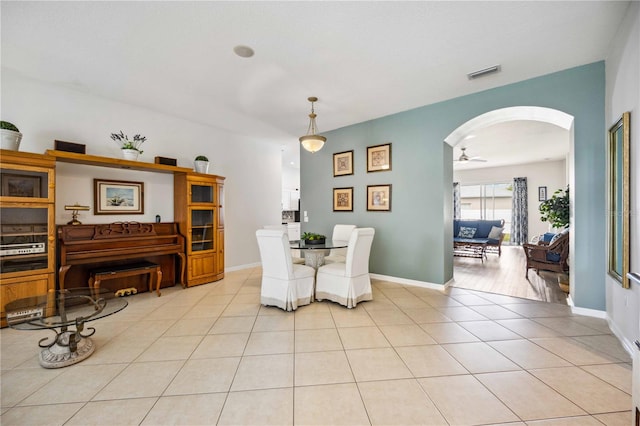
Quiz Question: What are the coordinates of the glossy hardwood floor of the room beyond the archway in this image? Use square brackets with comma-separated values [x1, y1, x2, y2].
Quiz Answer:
[451, 246, 568, 305]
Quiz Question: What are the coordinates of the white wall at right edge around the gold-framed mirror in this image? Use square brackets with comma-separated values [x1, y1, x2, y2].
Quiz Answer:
[603, 2, 640, 350]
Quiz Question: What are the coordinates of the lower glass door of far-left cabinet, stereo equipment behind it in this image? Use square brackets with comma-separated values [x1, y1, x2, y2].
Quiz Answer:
[0, 207, 49, 273]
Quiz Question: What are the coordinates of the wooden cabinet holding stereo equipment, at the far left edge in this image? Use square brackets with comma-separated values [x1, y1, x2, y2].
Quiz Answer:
[0, 150, 56, 327]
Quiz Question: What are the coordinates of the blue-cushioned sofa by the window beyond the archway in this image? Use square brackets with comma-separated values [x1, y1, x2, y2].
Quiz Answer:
[453, 219, 504, 256]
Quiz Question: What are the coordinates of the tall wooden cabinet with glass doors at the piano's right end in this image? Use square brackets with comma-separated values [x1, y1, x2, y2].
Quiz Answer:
[174, 173, 224, 287]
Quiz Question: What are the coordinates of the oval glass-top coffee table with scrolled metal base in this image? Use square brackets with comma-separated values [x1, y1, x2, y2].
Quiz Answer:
[5, 287, 127, 368]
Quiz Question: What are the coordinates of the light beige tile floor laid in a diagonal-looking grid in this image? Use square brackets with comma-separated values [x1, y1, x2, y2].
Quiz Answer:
[0, 268, 631, 426]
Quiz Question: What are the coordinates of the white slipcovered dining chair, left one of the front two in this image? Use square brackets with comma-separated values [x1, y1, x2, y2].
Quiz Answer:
[256, 229, 315, 311]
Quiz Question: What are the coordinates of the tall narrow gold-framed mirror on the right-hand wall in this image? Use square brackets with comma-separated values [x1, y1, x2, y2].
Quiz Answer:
[608, 112, 630, 288]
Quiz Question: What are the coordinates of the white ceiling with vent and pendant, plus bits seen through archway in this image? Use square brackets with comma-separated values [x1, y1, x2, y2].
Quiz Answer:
[0, 1, 629, 170]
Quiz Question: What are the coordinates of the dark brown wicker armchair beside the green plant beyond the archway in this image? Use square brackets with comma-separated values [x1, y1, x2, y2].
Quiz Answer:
[522, 229, 569, 278]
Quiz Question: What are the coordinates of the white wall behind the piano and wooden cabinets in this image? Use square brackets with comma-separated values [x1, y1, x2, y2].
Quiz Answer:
[1, 69, 282, 268]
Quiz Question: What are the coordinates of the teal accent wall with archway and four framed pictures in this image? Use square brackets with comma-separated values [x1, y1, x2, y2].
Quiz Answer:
[300, 62, 606, 310]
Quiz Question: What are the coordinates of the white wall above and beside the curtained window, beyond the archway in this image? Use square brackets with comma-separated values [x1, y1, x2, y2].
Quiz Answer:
[453, 160, 567, 240]
